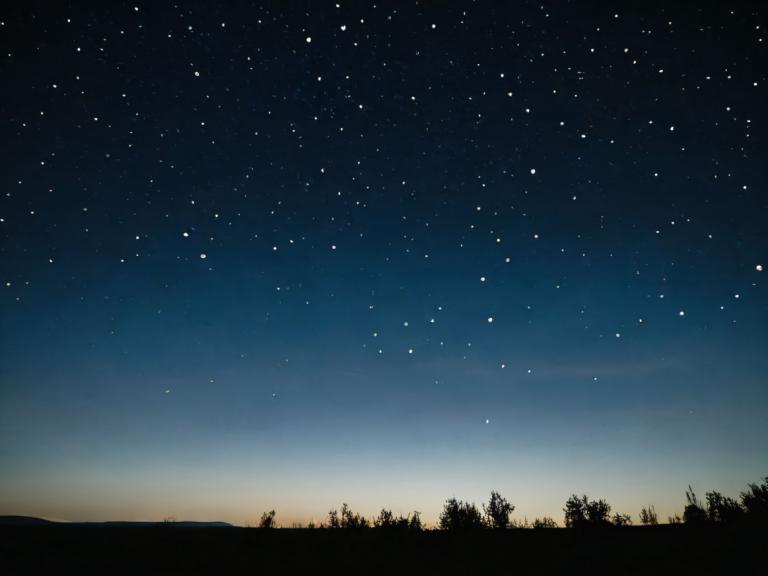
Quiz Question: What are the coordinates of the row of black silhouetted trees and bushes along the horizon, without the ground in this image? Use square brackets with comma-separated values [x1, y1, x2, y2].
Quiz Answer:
[258, 476, 768, 531]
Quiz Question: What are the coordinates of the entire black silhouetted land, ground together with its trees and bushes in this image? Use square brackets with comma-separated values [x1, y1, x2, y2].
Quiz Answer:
[0, 477, 768, 576]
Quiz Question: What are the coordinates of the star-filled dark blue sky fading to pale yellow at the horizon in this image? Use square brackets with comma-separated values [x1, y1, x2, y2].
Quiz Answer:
[0, 1, 768, 525]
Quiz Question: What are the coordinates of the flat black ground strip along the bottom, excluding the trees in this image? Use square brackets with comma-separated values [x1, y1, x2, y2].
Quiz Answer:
[0, 525, 768, 576]
